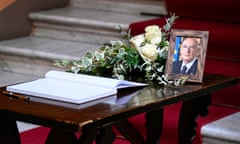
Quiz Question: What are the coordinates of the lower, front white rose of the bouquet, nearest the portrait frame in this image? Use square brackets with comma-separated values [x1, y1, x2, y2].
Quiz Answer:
[139, 43, 158, 62]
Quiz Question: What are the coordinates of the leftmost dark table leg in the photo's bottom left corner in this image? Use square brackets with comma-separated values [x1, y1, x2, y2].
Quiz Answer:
[0, 112, 21, 144]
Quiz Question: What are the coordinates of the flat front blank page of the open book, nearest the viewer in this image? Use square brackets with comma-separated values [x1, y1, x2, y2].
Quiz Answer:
[7, 78, 117, 104]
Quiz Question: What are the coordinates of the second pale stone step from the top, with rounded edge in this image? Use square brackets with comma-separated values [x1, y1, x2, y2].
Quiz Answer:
[29, 6, 156, 44]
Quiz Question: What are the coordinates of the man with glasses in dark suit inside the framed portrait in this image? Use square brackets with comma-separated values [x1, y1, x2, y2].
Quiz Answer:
[172, 37, 199, 75]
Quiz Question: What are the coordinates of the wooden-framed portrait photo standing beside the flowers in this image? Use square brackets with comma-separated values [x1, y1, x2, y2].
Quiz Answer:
[165, 29, 209, 83]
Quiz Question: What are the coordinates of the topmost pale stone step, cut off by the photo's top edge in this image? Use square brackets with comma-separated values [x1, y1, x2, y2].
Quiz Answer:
[70, 0, 167, 15]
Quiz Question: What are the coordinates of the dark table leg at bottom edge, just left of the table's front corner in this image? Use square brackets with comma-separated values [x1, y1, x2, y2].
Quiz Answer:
[46, 128, 77, 144]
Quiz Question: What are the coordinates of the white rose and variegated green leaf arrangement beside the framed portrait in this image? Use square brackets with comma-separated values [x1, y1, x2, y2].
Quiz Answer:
[55, 14, 186, 85]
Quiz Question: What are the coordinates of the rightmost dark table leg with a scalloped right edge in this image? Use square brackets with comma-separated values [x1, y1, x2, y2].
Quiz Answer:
[178, 95, 211, 144]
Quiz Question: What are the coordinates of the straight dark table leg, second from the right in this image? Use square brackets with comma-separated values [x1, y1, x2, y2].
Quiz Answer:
[145, 109, 163, 144]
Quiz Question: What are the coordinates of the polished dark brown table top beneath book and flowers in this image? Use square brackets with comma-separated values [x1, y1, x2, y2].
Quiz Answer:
[0, 74, 239, 131]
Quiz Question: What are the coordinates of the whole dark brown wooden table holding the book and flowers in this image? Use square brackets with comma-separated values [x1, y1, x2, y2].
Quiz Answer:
[0, 74, 239, 144]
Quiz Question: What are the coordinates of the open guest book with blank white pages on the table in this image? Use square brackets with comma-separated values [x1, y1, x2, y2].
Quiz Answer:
[6, 71, 147, 108]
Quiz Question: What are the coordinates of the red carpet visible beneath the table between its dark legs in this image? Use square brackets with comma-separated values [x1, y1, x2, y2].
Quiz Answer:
[20, 103, 238, 144]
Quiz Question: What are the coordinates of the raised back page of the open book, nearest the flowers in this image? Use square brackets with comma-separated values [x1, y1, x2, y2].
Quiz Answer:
[45, 71, 147, 89]
